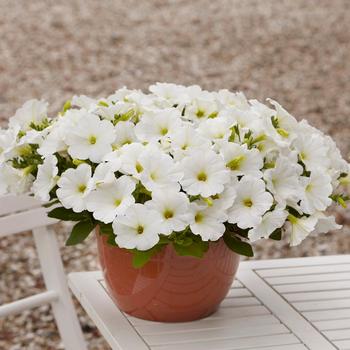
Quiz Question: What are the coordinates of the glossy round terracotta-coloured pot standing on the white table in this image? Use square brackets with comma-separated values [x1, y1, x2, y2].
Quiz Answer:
[97, 232, 239, 322]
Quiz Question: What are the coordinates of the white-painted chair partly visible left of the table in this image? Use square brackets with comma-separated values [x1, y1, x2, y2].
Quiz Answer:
[0, 196, 87, 350]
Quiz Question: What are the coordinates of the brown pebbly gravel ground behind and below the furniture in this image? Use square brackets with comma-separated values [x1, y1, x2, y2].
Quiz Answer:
[0, 0, 350, 350]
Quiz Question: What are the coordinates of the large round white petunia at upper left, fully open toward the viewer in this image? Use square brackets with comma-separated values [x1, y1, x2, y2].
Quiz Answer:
[65, 114, 115, 163]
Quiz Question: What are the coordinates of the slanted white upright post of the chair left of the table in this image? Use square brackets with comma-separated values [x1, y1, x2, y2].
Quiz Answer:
[33, 227, 86, 350]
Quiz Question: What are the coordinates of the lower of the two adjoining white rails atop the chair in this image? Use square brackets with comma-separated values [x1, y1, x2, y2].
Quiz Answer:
[0, 208, 58, 238]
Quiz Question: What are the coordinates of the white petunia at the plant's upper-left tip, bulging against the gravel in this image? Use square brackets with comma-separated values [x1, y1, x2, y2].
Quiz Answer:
[9, 100, 48, 131]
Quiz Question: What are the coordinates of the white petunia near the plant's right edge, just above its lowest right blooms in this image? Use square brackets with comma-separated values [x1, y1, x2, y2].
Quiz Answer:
[300, 170, 333, 214]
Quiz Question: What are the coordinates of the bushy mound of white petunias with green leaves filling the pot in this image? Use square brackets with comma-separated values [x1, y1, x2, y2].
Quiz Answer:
[0, 83, 350, 266]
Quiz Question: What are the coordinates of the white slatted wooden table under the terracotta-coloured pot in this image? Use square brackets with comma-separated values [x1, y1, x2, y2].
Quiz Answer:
[69, 255, 350, 350]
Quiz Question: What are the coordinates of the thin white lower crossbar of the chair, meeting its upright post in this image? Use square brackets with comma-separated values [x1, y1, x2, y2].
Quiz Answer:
[0, 290, 58, 317]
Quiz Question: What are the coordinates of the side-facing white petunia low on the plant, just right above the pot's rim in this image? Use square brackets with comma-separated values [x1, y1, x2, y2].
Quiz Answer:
[248, 208, 288, 242]
